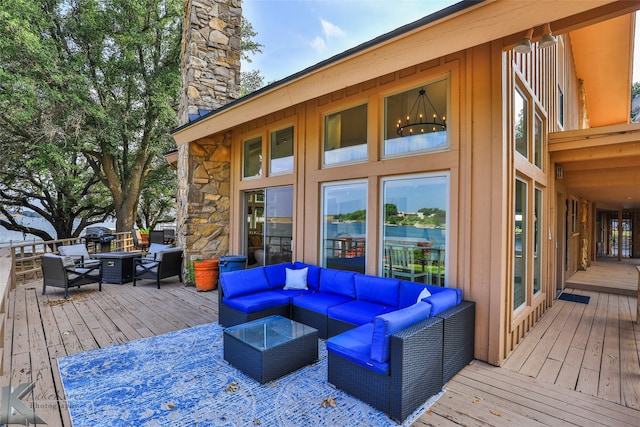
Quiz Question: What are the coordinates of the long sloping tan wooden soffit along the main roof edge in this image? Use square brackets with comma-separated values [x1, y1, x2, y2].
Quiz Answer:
[173, 0, 640, 144]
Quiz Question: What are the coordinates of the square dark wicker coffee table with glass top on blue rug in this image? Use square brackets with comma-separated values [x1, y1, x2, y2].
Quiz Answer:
[224, 316, 318, 384]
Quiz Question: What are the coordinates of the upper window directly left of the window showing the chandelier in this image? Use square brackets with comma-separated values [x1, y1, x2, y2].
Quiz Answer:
[323, 104, 367, 165]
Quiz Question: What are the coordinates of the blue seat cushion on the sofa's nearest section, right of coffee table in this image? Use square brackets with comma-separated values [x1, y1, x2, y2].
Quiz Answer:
[327, 323, 389, 375]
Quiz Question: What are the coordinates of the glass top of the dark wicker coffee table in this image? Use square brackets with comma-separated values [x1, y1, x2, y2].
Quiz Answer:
[224, 316, 316, 351]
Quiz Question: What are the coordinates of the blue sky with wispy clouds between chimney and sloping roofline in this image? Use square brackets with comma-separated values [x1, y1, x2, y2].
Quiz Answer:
[242, 0, 458, 84]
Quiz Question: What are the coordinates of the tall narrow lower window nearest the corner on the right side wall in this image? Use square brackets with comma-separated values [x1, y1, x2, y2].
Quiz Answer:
[513, 179, 528, 310]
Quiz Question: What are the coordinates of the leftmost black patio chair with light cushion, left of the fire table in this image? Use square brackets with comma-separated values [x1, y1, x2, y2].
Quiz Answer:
[40, 254, 102, 298]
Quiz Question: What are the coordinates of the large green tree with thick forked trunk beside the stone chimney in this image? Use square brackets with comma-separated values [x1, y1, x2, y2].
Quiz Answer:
[0, 0, 184, 236]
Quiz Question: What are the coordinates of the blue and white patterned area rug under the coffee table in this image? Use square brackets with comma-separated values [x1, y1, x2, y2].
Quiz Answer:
[58, 322, 442, 427]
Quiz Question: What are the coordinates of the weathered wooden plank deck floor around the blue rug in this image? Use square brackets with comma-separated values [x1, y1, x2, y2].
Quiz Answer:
[2, 280, 640, 426]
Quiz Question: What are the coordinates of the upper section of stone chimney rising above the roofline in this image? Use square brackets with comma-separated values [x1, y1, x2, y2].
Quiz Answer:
[179, 0, 242, 125]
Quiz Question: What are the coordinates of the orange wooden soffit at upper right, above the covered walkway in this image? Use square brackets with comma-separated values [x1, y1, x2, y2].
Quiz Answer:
[570, 14, 634, 127]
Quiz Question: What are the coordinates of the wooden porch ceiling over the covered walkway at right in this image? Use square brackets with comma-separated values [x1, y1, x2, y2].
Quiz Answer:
[549, 124, 640, 210]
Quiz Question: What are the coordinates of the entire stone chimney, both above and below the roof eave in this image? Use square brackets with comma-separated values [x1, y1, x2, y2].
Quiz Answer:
[176, 0, 242, 268]
